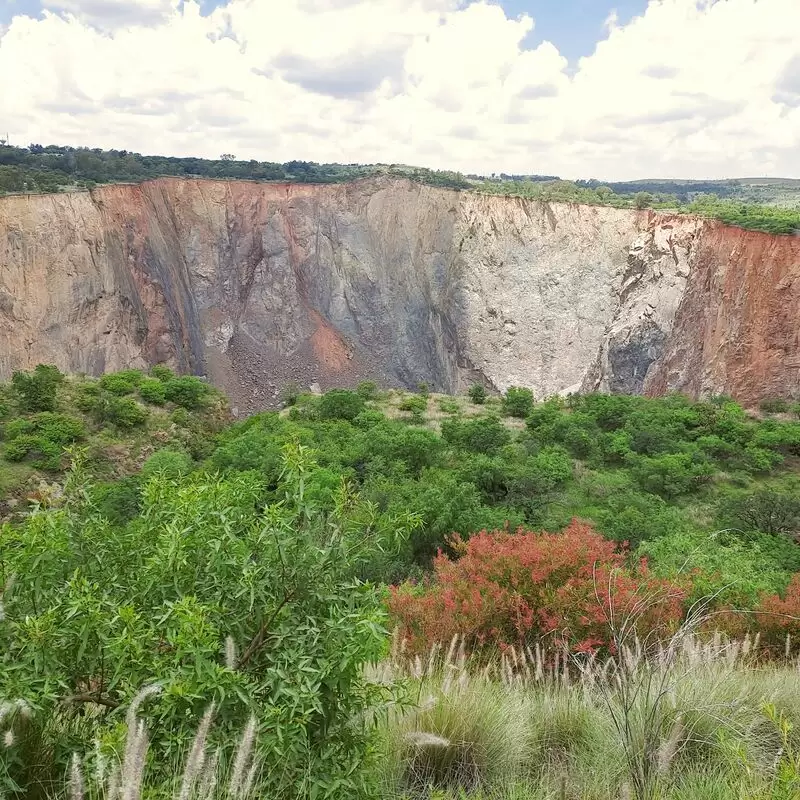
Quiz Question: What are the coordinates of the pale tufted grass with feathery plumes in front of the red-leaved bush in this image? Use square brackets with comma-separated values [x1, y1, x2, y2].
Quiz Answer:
[382, 636, 800, 800]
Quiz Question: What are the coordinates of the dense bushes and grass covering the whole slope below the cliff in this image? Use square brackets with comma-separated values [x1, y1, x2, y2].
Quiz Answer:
[0, 366, 800, 800]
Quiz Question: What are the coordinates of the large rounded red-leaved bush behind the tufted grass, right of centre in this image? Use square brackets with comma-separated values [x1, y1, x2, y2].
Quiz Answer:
[389, 520, 686, 652]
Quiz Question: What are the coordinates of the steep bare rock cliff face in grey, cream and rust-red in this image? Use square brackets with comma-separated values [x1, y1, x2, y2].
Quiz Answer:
[0, 179, 800, 412]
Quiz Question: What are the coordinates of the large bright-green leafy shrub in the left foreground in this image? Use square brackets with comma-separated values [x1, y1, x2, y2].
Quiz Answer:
[0, 446, 404, 800]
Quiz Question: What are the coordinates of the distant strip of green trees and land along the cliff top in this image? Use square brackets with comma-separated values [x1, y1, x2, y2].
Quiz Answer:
[0, 144, 800, 234]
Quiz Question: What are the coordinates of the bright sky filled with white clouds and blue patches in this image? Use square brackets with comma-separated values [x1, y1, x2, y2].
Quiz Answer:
[0, 0, 800, 180]
